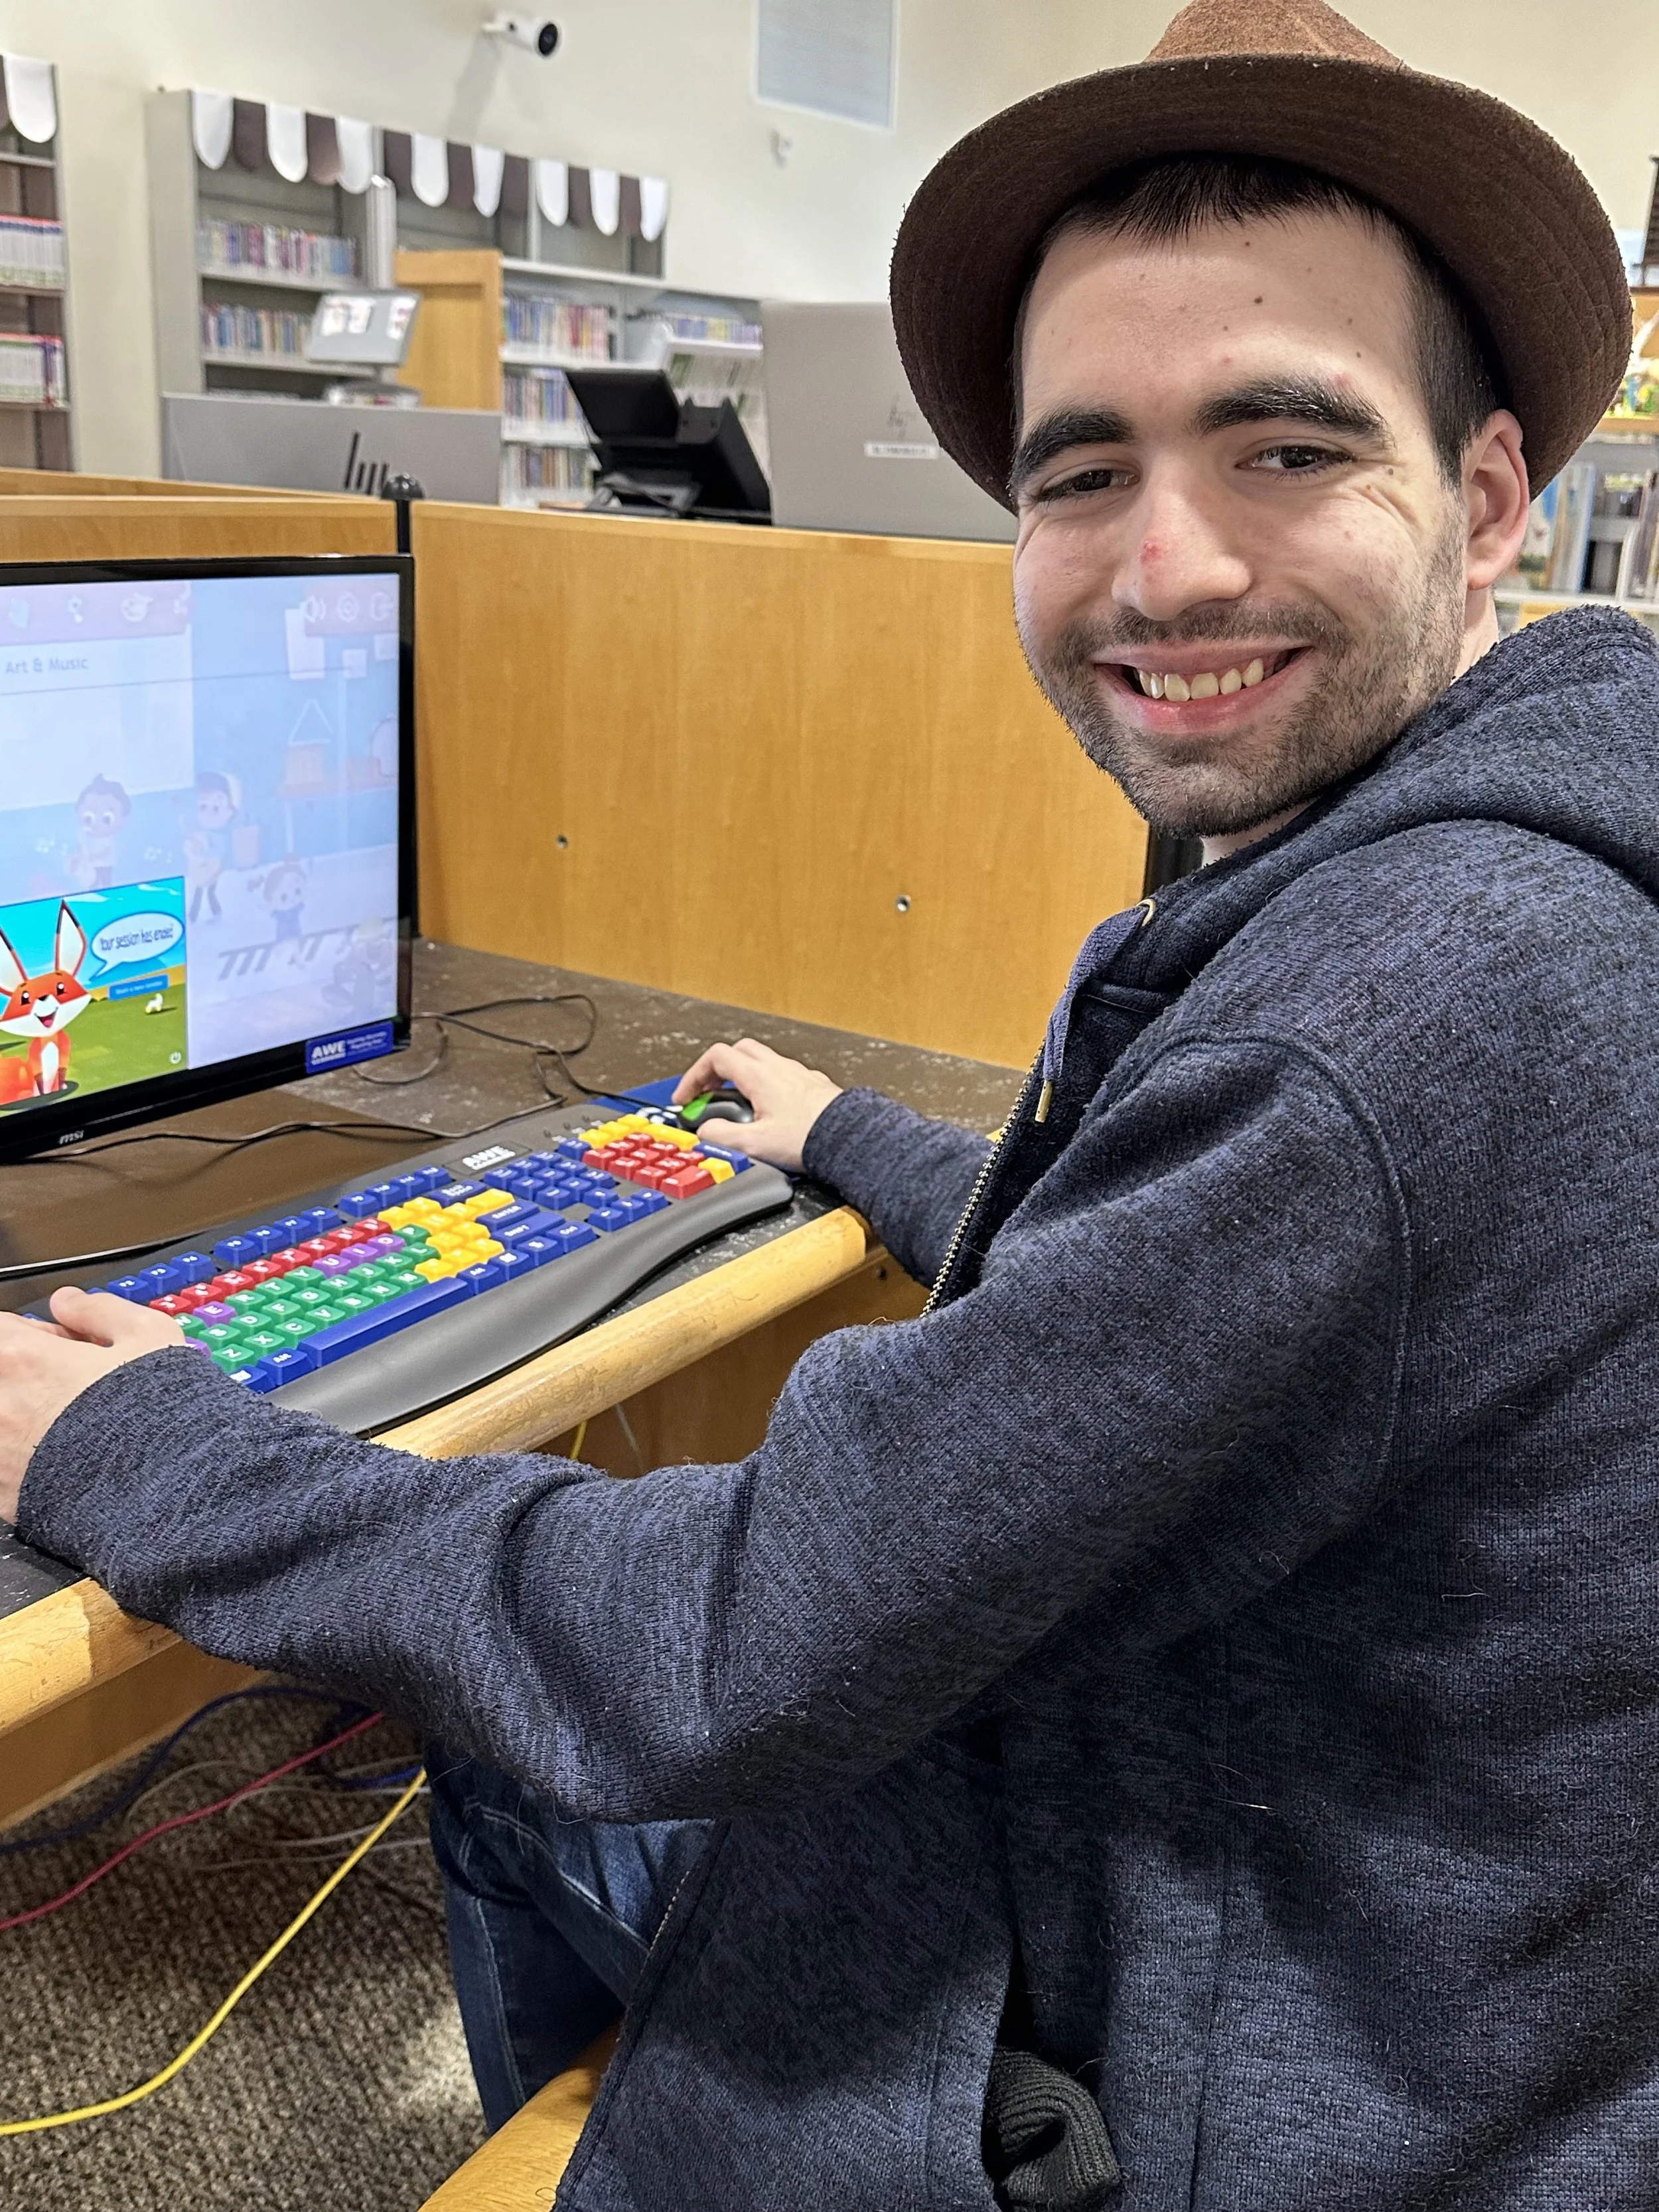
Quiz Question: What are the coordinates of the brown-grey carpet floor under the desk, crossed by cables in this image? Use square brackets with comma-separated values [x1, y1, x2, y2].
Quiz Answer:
[0, 1696, 484, 2212]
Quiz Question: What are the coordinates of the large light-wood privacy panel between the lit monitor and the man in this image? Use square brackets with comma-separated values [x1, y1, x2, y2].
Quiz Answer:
[413, 504, 1146, 1064]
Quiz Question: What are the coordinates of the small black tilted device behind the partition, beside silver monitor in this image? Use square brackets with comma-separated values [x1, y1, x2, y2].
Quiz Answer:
[564, 365, 772, 522]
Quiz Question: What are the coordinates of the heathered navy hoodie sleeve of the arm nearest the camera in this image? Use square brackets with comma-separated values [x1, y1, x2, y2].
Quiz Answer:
[20, 1044, 1407, 1820]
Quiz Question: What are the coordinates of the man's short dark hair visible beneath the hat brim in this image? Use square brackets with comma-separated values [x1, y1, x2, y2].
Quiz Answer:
[1015, 153, 1504, 484]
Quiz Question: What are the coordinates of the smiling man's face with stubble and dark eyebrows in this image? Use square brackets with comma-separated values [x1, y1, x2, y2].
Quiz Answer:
[1013, 214, 1473, 838]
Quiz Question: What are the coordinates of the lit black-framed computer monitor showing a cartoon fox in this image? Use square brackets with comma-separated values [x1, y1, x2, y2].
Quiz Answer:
[0, 555, 413, 1159]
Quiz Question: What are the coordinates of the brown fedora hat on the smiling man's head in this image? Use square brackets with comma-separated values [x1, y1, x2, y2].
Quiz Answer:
[891, 0, 1630, 504]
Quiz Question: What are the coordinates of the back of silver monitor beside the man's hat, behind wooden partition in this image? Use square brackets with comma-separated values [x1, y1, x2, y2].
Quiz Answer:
[761, 299, 1015, 544]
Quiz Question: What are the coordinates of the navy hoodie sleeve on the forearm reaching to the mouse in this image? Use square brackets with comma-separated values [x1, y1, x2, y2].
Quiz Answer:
[803, 1090, 991, 1283]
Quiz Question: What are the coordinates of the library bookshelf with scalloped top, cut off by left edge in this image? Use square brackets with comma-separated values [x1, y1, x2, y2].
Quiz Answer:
[0, 58, 75, 469]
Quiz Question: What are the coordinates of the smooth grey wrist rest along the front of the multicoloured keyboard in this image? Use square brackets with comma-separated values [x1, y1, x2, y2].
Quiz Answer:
[265, 1165, 792, 1434]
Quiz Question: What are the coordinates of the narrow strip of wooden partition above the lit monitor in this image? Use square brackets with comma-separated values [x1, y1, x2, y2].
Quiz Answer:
[0, 495, 398, 559]
